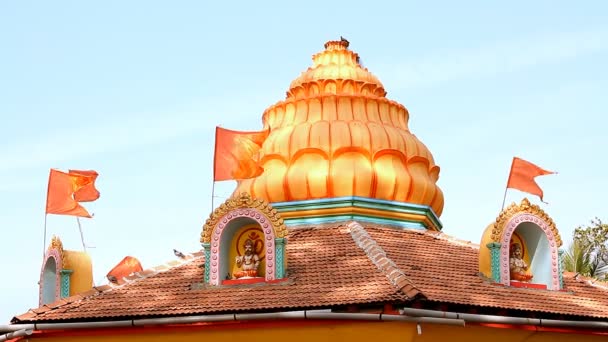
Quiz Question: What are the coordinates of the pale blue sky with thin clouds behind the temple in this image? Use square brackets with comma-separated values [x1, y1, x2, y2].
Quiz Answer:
[0, 1, 608, 323]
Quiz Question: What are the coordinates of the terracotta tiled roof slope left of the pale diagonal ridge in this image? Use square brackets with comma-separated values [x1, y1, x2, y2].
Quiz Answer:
[15, 225, 417, 322]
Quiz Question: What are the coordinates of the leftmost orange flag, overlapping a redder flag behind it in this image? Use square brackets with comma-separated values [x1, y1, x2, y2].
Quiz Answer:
[46, 169, 94, 217]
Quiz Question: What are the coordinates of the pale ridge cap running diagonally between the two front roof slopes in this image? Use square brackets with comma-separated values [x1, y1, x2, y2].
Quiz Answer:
[346, 221, 422, 298]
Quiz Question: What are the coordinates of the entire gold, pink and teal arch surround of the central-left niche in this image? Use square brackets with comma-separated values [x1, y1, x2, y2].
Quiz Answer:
[201, 193, 287, 285]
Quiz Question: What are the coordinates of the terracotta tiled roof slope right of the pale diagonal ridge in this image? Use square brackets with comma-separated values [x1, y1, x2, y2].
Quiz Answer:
[366, 226, 608, 319]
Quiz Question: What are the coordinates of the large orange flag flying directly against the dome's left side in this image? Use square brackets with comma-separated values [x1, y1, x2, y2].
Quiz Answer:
[213, 127, 268, 181]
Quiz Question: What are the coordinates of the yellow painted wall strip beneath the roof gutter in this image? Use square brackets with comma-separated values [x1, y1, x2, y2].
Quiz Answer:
[30, 321, 608, 342]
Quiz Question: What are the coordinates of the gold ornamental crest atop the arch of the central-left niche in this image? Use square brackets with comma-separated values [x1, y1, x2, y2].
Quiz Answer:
[200, 192, 287, 243]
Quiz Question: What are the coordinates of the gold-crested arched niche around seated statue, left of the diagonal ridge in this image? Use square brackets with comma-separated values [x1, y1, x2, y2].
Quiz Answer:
[201, 193, 287, 285]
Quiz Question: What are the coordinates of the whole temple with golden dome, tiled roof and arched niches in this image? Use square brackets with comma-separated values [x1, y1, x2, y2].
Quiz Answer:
[0, 39, 608, 342]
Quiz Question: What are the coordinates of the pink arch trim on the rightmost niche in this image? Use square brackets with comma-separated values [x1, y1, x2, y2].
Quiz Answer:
[500, 213, 560, 290]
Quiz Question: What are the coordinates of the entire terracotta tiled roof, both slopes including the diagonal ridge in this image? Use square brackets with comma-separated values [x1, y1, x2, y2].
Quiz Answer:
[13, 222, 608, 323]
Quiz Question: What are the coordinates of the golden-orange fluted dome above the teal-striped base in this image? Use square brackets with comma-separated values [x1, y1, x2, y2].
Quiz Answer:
[235, 40, 443, 216]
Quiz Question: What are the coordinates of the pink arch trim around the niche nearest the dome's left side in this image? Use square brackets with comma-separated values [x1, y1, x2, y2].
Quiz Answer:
[209, 208, 275, 285]
